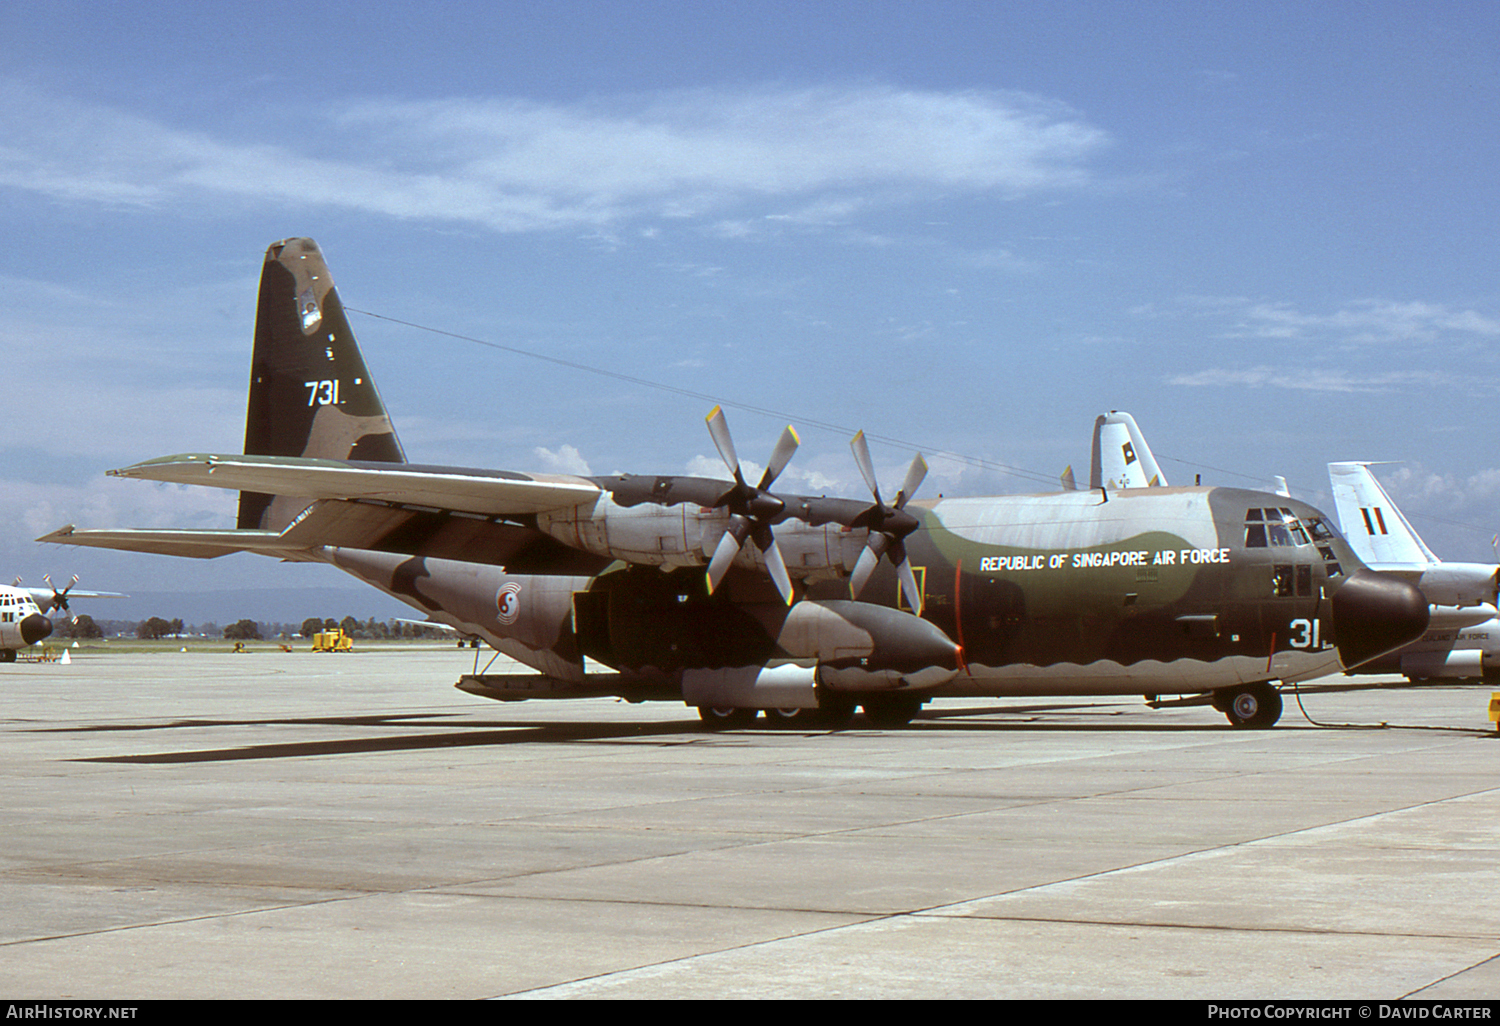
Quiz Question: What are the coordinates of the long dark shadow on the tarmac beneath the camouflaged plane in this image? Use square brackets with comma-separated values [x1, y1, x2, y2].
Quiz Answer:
[47, 704, 1233, 764]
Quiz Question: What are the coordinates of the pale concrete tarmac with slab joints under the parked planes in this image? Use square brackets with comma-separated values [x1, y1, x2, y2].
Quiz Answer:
[0, 647, 1500, 1001]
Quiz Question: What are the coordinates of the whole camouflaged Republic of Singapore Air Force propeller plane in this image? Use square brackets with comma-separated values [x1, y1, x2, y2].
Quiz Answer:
[41, 239, 1428, 728]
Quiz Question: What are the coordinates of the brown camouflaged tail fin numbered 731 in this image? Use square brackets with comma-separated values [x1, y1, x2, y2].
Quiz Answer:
[237, 239, 407, 531]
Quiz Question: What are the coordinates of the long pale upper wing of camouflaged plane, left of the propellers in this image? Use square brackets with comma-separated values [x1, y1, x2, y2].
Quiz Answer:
[110, 453, 603, 515]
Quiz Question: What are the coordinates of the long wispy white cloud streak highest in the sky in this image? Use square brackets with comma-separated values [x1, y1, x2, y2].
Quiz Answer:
[0, 84, 1107, 231]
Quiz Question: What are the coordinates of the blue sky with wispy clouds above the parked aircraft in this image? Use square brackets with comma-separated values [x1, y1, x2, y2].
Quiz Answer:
[0, 0, 1500, 618]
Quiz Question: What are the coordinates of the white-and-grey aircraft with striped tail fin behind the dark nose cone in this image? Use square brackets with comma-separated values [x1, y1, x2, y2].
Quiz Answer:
[1328, 464, 1500, 680]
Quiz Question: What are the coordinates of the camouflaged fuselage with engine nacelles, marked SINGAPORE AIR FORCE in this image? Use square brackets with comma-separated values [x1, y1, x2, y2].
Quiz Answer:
[324, 479, 1425, 695]
